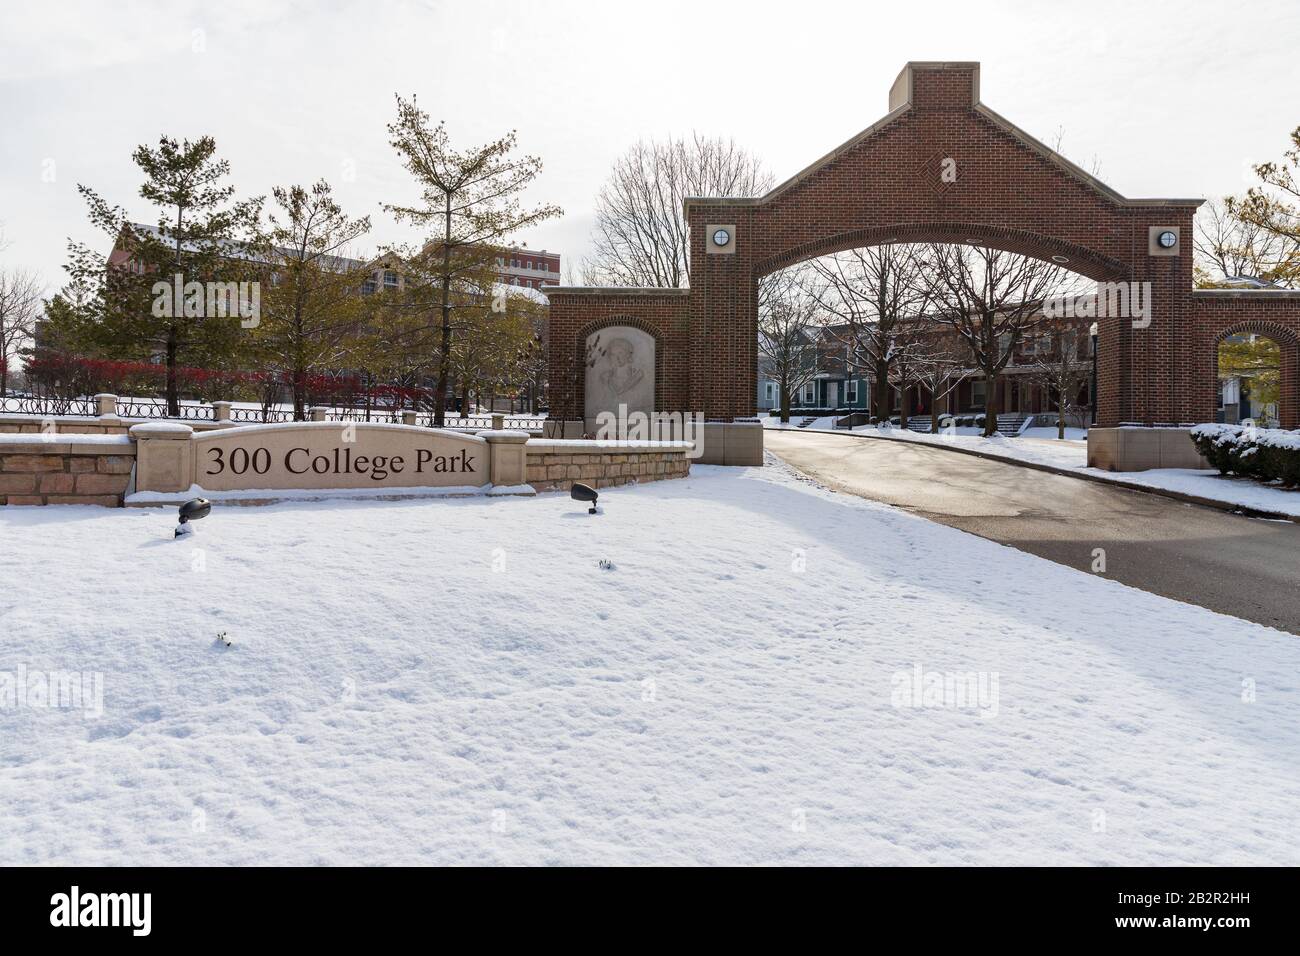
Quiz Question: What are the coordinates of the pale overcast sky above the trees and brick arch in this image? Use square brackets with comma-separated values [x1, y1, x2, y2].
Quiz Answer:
[0, 0, 1300, 289]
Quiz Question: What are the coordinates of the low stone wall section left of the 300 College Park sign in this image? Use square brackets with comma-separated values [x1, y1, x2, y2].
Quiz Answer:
[0, 434, 135, 507]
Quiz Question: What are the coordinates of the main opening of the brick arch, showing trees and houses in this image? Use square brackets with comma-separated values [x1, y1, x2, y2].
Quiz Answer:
[757, 241, 1097, 438]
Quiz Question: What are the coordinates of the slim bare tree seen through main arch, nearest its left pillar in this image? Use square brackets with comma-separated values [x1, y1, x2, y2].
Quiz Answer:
[758, 268, 822, 423]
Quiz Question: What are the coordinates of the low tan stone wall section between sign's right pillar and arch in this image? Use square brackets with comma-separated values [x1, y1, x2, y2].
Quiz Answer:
[525, 438, 690, 492]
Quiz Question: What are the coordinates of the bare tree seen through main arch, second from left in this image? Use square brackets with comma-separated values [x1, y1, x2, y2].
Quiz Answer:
[811, 246, 930, 421]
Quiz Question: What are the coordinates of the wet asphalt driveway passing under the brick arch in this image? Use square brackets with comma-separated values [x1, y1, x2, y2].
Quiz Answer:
[763, 431, 1300, 633]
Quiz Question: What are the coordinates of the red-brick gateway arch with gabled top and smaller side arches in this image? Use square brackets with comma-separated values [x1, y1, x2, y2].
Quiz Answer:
[546, 62, 1300, 434]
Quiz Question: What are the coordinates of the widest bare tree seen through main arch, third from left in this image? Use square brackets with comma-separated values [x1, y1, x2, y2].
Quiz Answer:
[928, 245, 1080, 436]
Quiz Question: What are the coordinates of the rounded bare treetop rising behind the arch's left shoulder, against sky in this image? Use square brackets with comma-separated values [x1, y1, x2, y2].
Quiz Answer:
[581, 133, 772, 289]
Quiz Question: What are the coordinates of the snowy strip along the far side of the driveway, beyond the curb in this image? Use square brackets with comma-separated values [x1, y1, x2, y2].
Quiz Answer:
[763, 416, 1300, 518]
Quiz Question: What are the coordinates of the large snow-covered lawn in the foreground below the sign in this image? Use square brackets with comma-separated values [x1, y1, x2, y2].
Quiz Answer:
[0, 466, 1300, 866]
